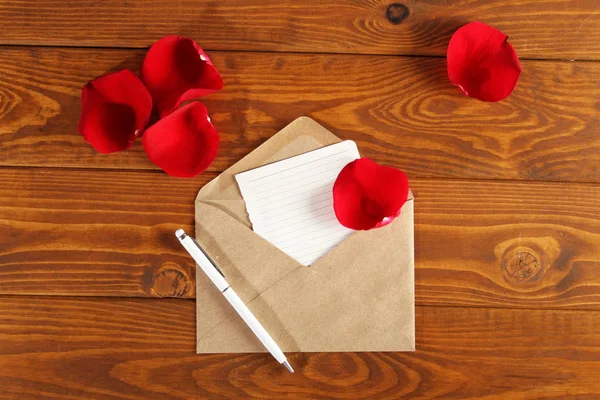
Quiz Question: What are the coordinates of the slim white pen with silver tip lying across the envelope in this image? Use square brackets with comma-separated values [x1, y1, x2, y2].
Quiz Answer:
[175, 229, 294, 372]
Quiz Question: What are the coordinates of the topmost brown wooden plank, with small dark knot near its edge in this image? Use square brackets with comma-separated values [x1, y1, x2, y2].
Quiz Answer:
[0, 0, 600, 60]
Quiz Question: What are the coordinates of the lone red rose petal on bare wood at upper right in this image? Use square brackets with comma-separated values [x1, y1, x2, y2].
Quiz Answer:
[447, 21, 521, 101]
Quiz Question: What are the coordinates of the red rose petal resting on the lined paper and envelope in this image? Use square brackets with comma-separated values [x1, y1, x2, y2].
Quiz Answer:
[333, 158, 408, 230]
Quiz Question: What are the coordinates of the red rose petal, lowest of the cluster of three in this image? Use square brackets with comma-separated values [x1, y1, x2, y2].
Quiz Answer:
[142, 101, 219, 178]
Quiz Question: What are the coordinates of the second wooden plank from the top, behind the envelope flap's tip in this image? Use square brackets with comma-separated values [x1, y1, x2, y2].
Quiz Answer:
[0, 47, 600, 182]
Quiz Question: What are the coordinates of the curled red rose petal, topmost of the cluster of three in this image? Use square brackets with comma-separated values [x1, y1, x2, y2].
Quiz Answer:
[141, 36, 223, 117]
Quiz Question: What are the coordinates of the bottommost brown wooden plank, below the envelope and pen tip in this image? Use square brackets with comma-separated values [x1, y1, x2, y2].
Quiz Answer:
[0, 297, 600, 400]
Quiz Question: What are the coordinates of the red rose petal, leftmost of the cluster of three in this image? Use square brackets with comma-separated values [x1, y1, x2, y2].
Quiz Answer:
[78, 69, 152, 153]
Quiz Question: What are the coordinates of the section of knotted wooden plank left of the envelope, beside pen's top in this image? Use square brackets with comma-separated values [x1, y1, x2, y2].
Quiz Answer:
[0, 169, 205, 297]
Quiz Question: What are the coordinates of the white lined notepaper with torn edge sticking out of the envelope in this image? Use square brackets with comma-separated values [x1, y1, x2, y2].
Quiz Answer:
[235, 140, 360, 265]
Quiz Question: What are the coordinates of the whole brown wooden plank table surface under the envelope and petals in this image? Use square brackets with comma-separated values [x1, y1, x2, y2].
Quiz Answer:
[0, 0, 600, 399]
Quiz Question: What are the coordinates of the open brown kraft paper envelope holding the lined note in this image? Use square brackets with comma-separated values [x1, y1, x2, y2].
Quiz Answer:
[196, 117, 415, 353]
